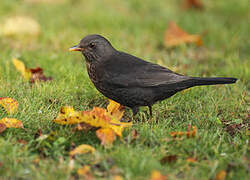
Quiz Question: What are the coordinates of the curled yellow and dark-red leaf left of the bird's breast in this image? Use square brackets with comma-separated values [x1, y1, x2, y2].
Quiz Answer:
[12, 58, 52, 83]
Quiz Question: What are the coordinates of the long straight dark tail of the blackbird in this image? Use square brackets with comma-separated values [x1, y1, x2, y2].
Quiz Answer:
[188, 77, 237, 86]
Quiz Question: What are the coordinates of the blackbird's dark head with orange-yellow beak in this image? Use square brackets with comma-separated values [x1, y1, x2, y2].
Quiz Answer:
[69, 34, 115, 62]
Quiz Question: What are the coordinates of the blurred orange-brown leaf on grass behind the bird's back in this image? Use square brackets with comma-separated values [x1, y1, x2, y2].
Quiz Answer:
[164, 21, 202, 47]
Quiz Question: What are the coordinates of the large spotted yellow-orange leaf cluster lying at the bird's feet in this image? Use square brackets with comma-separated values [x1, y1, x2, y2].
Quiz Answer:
[53, 101, 132, 145]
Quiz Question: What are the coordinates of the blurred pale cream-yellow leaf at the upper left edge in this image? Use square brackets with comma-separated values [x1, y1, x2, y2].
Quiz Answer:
[0, 16, 40, 36]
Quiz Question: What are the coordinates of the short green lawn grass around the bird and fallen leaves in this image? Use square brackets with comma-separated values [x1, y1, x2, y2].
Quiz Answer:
[0, 0, 250, 179]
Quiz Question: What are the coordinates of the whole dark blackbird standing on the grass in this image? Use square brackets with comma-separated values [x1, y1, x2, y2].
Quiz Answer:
[69, 34, 237, 116]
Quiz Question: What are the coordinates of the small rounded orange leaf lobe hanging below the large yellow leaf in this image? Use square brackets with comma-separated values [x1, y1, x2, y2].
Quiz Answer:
[96, 128, 116, 146]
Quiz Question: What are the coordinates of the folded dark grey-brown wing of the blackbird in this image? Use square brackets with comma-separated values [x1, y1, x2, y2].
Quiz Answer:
[101, 52, 188, 87]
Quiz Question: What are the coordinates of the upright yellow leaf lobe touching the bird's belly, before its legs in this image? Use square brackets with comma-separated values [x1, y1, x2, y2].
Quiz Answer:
[107, 99, 124, 120]
